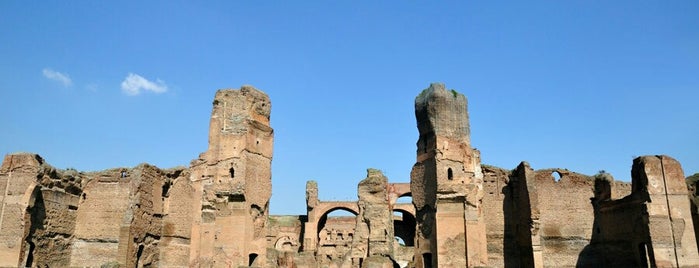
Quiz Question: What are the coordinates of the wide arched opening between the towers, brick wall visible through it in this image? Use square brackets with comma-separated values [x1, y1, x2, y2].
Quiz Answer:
[316, 207, 357, 262]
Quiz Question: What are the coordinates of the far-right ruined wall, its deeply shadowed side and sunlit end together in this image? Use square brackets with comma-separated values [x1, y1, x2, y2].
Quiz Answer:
[579, 156, 699, 267]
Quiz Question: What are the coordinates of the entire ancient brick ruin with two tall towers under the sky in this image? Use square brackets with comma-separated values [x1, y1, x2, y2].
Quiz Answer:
[0, 84, 699, 268]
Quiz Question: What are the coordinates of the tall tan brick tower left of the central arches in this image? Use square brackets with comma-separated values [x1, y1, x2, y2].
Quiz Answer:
[190, 86, 274, 267]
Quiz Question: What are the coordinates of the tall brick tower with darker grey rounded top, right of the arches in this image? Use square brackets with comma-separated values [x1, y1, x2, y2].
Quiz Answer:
[410, 83, 488, 267]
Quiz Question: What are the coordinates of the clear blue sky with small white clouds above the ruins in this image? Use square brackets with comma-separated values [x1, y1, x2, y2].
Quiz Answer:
[0, 1, 699, 214]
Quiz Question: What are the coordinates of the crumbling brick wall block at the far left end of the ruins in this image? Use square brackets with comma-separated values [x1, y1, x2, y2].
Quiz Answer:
[0, 153, 85, 266]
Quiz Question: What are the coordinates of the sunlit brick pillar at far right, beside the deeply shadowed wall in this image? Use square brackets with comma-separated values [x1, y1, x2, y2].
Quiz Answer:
[631, 155, 699, 267]
